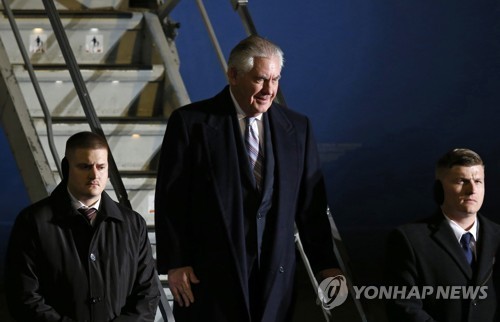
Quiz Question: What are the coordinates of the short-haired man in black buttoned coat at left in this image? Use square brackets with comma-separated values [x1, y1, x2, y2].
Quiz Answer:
[5, 132, 159, 322]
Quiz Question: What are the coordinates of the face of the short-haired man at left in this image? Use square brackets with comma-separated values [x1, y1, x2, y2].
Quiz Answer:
[67, 149, 108, 206]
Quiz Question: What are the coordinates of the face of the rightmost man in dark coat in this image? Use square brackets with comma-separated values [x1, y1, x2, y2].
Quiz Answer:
[440, 165, 484, 218]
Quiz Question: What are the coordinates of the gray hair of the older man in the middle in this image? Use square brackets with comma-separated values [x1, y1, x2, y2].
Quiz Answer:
[227, 35, 285, 73]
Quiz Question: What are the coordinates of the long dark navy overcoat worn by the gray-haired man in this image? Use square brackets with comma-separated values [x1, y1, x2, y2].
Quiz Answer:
[155, 87, 336, 322]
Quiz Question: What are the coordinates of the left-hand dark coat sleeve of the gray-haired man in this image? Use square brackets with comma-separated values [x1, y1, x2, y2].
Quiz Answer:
[155, 111, 191, 274]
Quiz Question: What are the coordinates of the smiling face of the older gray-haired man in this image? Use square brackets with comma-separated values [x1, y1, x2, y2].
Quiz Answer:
[228, 56, 281, 116]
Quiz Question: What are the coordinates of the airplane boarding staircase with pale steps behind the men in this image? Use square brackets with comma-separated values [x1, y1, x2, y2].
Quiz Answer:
[0, 0, 368, 321]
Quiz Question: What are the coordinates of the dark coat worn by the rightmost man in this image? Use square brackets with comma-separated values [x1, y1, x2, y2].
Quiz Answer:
[387, 210, 500, 322]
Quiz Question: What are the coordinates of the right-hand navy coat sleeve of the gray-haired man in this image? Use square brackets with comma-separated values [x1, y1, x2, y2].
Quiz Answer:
[296, 119, 338, 273]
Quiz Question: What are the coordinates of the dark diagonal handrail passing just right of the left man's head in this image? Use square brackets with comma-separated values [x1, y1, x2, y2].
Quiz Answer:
[42, 0, 132, 208]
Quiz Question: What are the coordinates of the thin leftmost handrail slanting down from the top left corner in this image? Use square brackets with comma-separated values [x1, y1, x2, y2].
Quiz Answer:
[2, 0, 63, 178]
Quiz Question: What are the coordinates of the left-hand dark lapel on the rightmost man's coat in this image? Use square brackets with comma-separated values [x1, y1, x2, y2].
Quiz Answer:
[431, 214, 472, 279]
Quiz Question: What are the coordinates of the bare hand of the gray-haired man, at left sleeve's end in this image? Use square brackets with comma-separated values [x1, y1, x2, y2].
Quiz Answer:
[168, 266, 200, 307]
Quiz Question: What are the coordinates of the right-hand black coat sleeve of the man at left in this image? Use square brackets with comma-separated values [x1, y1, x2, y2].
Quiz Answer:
[113, 213, 160, 322]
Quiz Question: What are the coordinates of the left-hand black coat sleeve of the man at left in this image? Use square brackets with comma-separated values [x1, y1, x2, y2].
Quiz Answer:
[5, 210, 72, 322]
